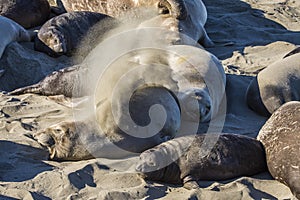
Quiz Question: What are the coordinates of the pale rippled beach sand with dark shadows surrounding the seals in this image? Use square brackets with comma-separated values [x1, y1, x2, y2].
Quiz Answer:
[0, 0, 300, 200]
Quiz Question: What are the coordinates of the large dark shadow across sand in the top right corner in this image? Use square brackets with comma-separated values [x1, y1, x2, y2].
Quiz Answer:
[203, 0, 300, 59]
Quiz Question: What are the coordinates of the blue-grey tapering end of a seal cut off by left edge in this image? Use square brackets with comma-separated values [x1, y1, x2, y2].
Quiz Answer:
[0, 16, 31, 58]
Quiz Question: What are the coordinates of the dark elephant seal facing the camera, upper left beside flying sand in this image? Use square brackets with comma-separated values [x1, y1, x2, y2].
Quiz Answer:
[34, 11, 115, 57]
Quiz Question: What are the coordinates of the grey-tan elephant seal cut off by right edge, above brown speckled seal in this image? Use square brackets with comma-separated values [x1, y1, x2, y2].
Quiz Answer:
[246, 48, 300, 117]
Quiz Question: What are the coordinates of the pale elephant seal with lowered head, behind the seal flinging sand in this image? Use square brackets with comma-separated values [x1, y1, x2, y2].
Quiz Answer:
[91, 45, 226, 124]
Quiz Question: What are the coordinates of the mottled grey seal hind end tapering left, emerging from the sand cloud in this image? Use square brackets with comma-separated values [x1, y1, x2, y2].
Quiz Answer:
[8, 65, 88, 97]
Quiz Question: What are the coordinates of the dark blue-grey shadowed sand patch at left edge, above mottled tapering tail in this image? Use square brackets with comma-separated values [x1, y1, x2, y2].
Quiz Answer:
[0, 42, 71, 91]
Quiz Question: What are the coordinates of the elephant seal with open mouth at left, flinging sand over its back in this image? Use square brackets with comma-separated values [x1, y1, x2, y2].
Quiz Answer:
[33, 87, 180, 160]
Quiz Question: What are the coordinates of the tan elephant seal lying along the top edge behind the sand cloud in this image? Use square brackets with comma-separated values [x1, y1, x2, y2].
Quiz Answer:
[62, 0, 214, 47]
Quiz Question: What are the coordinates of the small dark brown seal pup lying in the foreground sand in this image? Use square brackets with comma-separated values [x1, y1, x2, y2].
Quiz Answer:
[136, 134, 266, 189]
